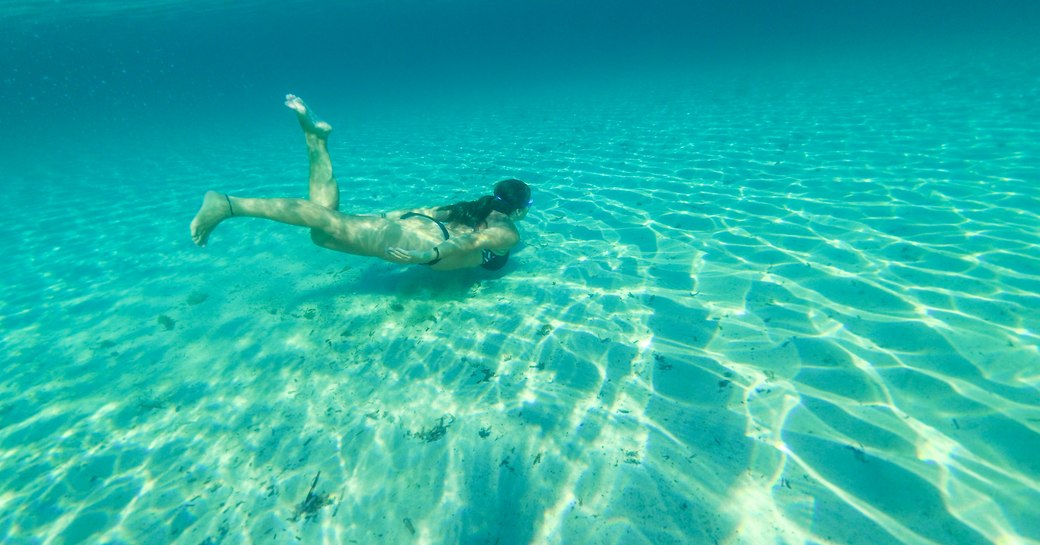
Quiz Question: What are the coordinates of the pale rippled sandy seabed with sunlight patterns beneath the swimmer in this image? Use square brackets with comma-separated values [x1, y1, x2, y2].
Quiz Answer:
[0, 59, 1040, 545]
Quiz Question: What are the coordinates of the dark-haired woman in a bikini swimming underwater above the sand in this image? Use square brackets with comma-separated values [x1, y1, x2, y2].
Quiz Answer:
[191, 95, 531, 270]
